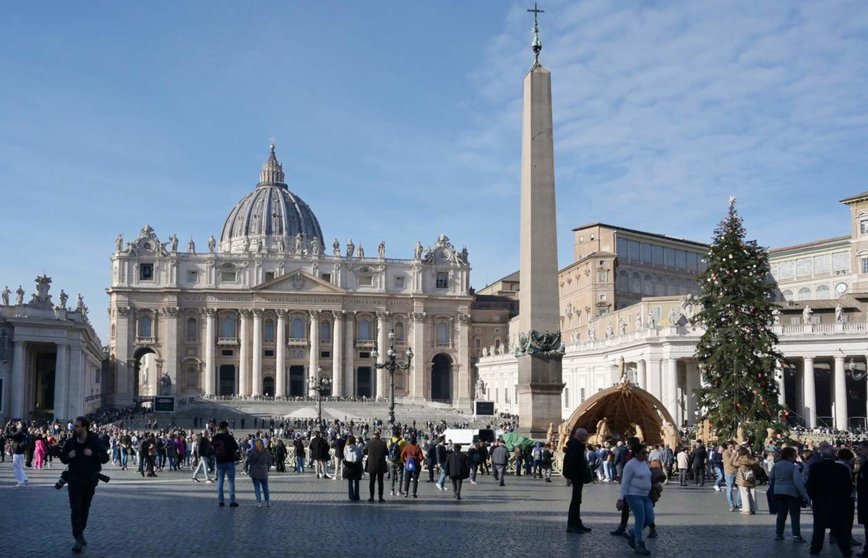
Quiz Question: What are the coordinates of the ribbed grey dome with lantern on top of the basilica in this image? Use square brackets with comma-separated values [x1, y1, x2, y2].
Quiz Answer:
[220, 145, 323, 253]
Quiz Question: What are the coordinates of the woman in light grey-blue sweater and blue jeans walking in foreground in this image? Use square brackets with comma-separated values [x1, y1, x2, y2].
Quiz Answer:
[615, 445, 654, 556]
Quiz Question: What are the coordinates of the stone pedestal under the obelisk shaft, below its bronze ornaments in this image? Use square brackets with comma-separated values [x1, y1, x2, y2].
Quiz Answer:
[517, 354, 564, 438]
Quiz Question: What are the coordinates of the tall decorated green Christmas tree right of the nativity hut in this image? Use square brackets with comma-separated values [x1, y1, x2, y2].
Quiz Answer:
[693, 198, 783, 442]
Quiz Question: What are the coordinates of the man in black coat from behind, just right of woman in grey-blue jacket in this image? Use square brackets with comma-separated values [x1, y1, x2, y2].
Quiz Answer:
[805, 445, 853, 556]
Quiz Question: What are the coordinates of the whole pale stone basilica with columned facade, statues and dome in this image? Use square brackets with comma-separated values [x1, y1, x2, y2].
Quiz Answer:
[107, 145, 473, 406]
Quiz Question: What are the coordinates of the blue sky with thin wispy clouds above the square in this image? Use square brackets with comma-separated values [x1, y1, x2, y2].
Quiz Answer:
[0, 0, 868, 342]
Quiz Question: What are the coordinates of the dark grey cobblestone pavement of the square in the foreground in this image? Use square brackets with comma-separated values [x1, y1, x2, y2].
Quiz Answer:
[0, 459, 836, 558]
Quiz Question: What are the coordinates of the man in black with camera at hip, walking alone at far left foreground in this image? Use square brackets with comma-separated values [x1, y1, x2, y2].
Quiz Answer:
[60, 417, 108, 553]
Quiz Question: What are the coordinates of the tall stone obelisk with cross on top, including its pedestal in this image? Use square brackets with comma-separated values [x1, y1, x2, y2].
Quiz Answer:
[515, 4, 564, 437]
